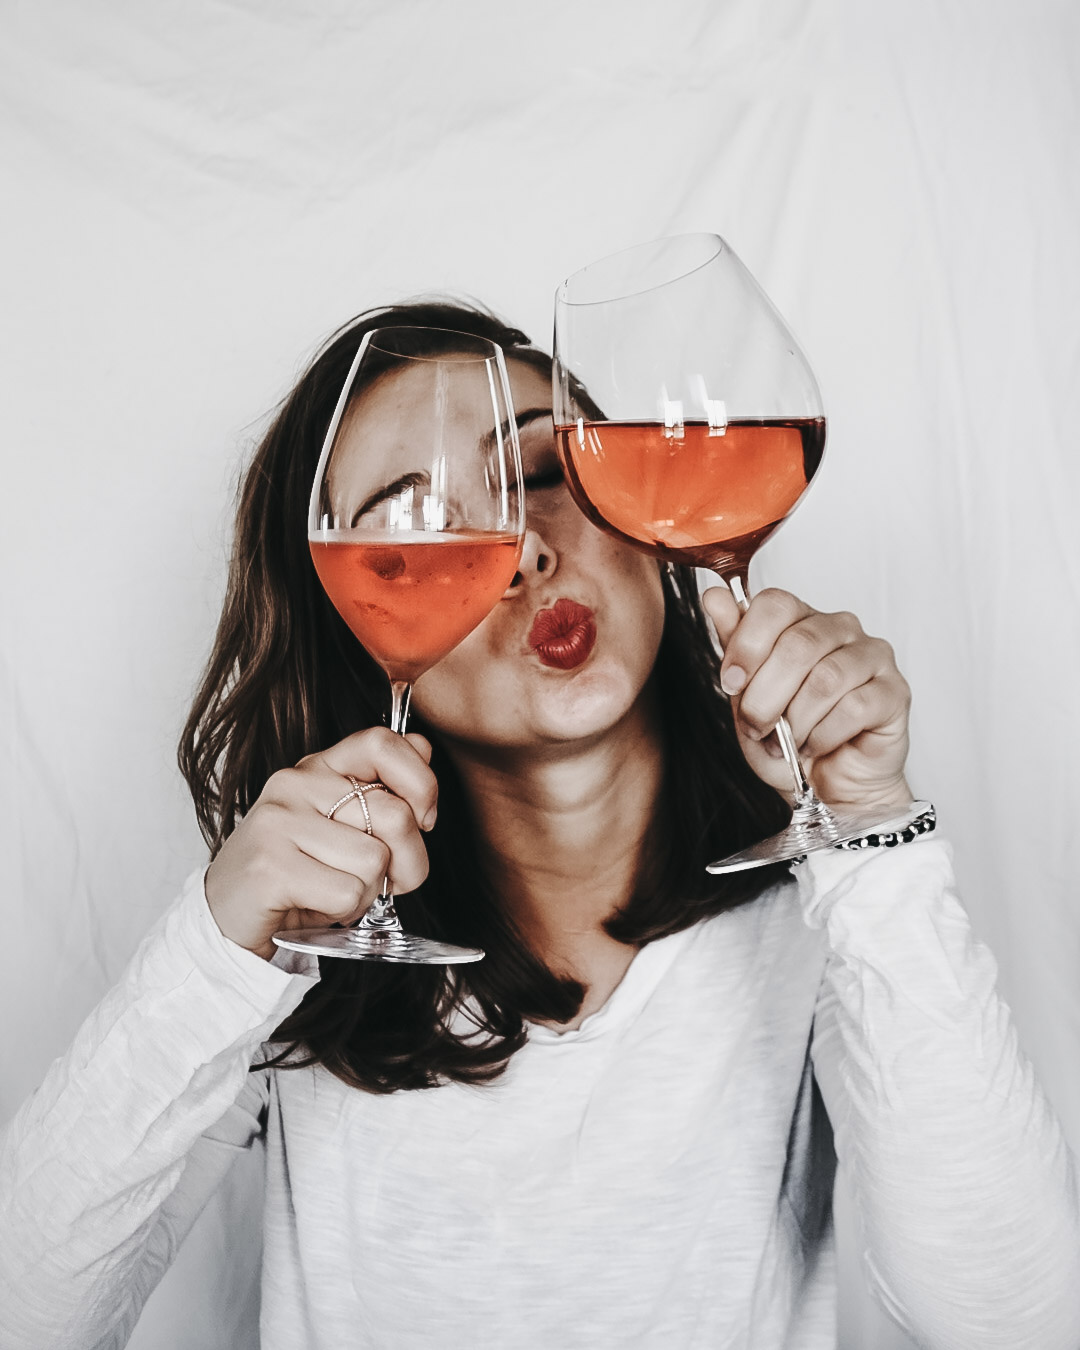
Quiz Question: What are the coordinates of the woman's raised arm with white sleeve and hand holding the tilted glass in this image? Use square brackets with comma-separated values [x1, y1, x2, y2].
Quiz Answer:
[705, 587, 1080, 1350]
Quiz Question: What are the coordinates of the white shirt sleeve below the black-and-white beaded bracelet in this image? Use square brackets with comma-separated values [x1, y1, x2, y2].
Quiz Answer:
[797, 840, 1080, 1350]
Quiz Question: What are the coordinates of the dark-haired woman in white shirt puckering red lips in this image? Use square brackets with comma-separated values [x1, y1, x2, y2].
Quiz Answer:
[0, 305, 1080, 1350]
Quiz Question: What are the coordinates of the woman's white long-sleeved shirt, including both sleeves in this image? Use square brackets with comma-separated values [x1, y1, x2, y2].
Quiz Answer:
[0, 840, 1080, 1350]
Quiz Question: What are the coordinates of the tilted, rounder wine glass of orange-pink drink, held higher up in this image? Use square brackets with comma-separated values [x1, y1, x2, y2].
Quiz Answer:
[554, 234, 926, 872]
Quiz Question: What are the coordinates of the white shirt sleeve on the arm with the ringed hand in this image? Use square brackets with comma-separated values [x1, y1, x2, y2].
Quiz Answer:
[0, 872, 317, 1350]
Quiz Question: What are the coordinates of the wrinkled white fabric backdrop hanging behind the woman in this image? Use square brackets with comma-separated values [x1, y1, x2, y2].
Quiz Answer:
[0, 0, 1080, 1350]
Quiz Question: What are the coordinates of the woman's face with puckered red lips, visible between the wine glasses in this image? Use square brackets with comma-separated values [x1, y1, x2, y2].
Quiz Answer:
[413, 359, 664, 749]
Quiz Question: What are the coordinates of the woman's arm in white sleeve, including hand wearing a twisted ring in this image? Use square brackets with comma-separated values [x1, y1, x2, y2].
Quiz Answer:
[0, 728, 436, 1350]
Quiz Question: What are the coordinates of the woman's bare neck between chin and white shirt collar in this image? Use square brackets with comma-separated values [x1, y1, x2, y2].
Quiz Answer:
[447, 698, 662, 982]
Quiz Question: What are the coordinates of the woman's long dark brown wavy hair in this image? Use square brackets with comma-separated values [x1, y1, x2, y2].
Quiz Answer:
[180, 301, 788, 1092]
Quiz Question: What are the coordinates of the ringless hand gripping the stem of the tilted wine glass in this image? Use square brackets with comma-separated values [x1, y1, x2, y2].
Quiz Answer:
[705, 586, 911, 807]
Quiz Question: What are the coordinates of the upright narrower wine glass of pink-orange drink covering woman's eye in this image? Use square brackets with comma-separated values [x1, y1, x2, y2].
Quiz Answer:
[274, 327, 525, 965]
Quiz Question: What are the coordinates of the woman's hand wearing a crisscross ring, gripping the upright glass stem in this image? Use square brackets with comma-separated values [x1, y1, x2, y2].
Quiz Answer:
[205, 726, 439, 961]
